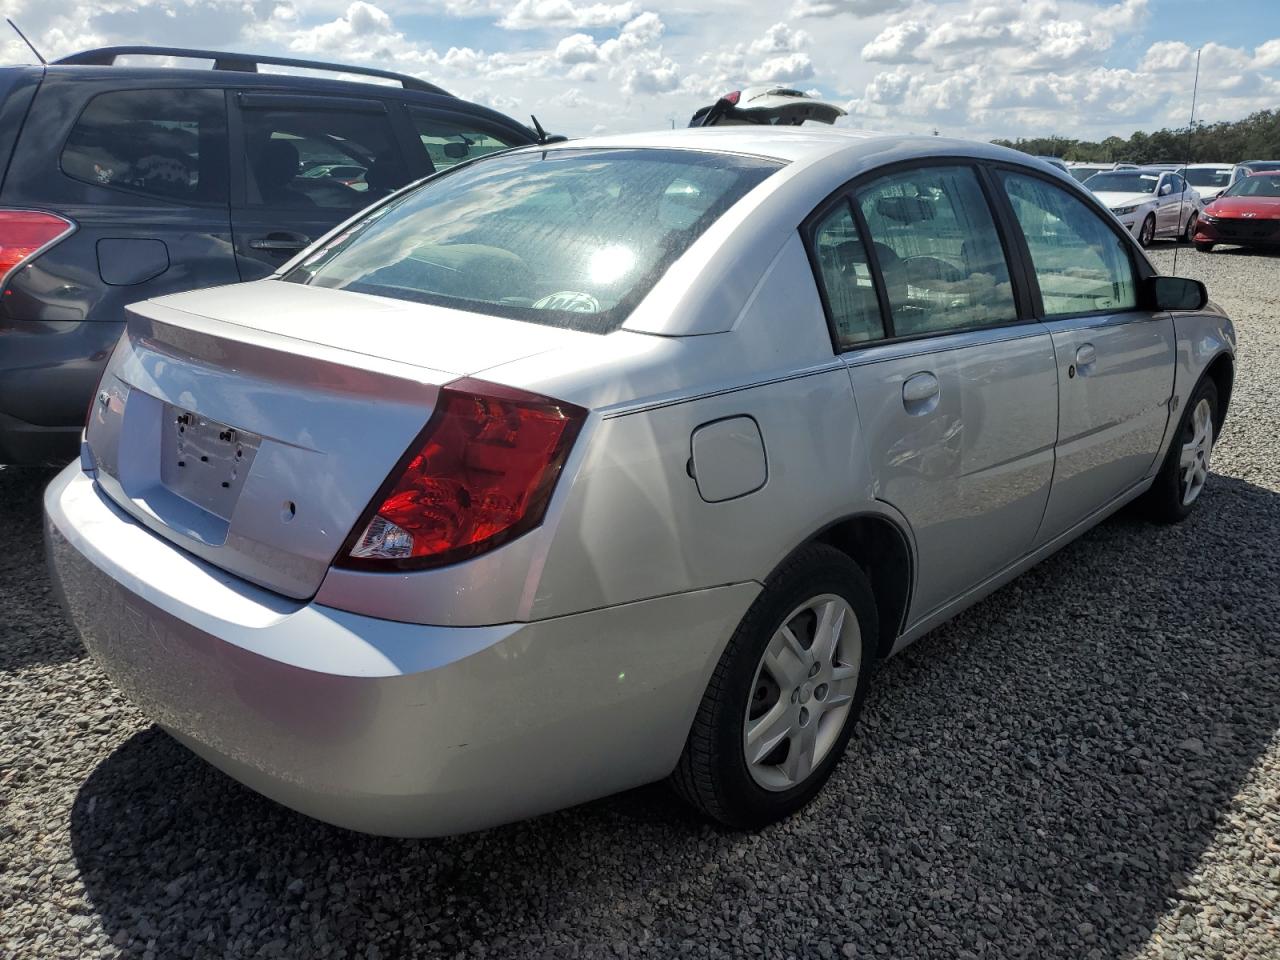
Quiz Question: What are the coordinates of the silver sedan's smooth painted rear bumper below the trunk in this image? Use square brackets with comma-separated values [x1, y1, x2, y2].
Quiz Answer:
[45, 465, 759, 836]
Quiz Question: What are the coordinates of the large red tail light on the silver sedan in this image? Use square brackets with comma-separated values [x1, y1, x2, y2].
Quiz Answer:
[338, 379, 586, 570]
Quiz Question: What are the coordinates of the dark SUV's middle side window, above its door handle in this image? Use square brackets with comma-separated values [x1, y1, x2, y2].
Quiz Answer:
[241, 95, 408, 211]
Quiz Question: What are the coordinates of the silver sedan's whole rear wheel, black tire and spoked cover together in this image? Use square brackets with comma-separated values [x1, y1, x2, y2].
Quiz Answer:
[671, 544, 879, 828]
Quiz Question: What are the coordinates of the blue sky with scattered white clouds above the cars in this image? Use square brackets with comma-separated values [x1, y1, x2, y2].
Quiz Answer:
[0, 0, 1280, 140]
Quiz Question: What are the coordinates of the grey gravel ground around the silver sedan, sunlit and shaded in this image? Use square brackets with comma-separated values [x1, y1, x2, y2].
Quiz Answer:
[0, 248, 1280, 960]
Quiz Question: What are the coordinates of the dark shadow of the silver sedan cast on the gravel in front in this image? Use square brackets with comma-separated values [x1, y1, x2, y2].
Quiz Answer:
[70, 476, 1280, 960]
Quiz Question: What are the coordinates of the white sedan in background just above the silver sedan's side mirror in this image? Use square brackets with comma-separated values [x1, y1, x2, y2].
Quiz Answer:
[1084, 166, 1204, 247]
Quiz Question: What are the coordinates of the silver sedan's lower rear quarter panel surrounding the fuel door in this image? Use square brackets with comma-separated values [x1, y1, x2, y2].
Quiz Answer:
[530, 367, 872, 618]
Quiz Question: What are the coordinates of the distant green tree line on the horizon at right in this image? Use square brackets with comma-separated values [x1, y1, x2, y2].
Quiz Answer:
[992, 110, 1280, 164]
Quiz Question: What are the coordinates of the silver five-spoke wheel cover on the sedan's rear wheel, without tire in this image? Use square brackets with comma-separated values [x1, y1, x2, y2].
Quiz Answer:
[742, 594, 861, 791]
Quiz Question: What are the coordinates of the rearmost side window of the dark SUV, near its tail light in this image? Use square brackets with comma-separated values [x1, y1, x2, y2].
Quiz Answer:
[61, 90, 227, 204]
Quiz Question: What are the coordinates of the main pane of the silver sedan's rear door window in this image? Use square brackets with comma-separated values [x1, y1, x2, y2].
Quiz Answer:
[856, 166, 1018, 337]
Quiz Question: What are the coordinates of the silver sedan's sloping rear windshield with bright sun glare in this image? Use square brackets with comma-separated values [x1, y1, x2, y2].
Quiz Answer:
[285, 150, 781, 333]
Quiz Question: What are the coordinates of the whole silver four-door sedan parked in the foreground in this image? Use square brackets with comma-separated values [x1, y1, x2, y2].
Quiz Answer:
[45, 127, 1234, 835]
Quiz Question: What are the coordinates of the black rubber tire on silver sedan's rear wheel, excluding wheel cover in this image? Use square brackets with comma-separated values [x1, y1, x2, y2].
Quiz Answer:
[713, 545, 878, 827]
